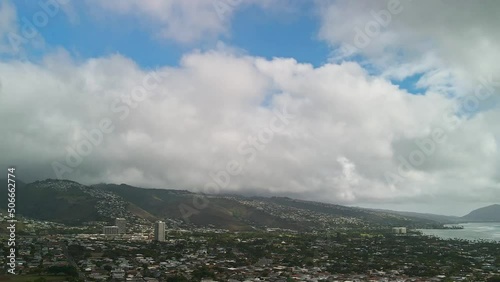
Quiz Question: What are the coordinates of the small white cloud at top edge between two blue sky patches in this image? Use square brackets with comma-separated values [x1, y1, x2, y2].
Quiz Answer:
[86, 0, 300, 44]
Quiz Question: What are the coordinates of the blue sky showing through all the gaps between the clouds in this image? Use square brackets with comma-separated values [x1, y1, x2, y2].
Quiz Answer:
[5, 1, 426, 94]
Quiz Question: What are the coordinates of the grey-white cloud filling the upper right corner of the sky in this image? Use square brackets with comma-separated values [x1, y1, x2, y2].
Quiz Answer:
[319, 0, 500, 95]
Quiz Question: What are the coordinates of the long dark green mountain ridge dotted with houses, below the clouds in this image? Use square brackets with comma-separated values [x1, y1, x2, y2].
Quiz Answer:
[3, 179, 494, 230]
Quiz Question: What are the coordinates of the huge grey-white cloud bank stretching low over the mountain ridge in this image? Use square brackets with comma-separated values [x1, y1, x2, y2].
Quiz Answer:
[0, 47, 498, 215]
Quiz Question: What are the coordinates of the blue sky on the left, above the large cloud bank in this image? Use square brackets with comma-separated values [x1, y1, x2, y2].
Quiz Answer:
[11, 1, 189, 68]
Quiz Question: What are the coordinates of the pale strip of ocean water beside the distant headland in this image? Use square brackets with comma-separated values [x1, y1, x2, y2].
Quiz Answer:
[420, 222, 500, 242]
